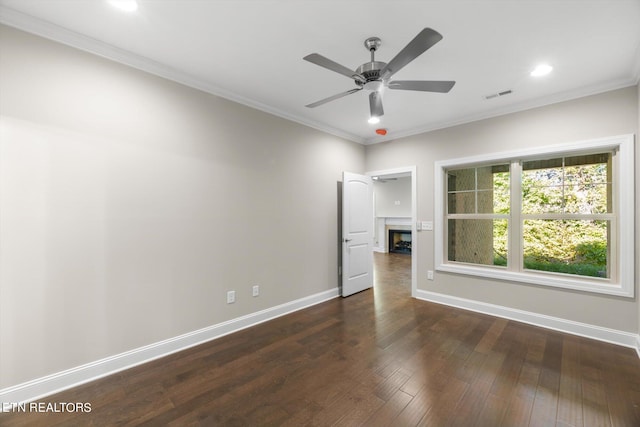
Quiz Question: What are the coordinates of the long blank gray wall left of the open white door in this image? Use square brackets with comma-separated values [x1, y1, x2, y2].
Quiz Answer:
[0, 26, 364, 388]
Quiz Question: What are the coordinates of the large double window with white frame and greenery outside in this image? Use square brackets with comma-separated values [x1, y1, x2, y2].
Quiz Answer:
[436, 136, 634, 296]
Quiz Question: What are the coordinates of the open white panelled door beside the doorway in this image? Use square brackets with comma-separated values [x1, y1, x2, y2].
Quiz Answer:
[342, 172, 373, 297]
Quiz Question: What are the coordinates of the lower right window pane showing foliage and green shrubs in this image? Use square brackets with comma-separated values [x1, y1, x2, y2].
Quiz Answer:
[523, 220, 609, 277]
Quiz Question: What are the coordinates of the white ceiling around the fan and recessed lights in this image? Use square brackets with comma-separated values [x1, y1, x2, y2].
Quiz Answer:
[0, 0, 640, 144]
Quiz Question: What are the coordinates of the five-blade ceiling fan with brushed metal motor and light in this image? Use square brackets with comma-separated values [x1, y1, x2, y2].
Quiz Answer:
[303, 28, 456, 118]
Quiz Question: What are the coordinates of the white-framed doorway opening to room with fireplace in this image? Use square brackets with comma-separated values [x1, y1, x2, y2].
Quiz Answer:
[366, 166, 418, 297]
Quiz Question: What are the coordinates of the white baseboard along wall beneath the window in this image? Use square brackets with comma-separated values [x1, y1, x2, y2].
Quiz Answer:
[416, 289, 640, 357]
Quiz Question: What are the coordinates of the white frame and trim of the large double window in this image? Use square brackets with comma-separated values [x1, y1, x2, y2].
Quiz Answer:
[434, 135, 635, 298]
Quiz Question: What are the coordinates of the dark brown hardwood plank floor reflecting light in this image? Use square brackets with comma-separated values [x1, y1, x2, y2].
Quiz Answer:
[0, 254, 640, 427]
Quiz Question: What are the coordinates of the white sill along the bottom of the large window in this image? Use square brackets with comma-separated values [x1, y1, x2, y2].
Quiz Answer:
[436, 264, 633, 298]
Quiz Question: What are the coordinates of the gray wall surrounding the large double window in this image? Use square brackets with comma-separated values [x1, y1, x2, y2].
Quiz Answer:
[366, 87, 640, 333]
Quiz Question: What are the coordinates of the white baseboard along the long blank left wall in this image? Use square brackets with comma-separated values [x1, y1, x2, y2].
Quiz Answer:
[0, 288, 339, 404]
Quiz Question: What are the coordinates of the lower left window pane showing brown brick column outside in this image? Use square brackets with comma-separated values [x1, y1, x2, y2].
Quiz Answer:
[447, 219, 508, 266]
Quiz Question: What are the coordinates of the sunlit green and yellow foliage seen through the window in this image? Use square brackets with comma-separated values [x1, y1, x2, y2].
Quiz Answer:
[493, 159, 610, 277]
